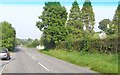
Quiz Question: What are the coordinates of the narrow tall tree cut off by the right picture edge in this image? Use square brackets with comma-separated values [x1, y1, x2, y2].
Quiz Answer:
[113, 2, 120, 33]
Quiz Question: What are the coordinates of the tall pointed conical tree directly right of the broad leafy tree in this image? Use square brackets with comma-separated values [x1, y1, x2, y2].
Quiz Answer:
[67, 0, 83, 39]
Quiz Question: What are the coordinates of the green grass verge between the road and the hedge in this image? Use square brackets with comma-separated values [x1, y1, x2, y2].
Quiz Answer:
[40, 50, 118, 73]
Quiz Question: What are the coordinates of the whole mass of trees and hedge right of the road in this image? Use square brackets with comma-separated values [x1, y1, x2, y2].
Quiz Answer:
[36, 0, 120, 52]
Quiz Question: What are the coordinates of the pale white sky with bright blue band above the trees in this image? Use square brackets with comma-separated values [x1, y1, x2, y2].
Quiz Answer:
[0, 0, 119, 39]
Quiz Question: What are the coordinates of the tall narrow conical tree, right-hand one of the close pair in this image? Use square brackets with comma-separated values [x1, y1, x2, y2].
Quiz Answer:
[81, 0, 95, 33]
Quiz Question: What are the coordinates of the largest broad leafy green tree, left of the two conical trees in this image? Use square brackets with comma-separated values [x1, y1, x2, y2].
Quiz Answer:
[36, 2, 67, 48]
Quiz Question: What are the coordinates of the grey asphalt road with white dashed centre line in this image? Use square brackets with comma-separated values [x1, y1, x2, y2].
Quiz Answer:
[0, 48, 95, 73]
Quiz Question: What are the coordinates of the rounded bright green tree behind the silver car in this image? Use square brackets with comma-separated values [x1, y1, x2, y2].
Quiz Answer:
[0, 21, 16, 51]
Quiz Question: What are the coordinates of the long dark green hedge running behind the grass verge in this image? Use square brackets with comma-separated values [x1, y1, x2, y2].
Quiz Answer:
[57, 37, 120, 53]
